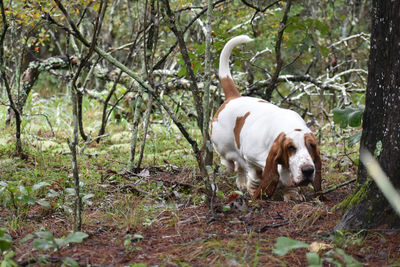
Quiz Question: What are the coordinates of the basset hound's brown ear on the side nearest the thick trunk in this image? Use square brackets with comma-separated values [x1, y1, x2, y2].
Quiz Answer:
[304, 133, 326, 200]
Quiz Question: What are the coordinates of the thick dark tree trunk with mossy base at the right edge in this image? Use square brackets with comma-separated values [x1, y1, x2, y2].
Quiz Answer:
[336, 0, 400, 229]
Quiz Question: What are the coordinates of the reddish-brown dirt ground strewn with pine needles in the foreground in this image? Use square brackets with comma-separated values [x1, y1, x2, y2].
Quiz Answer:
[1, 172, 400, 266]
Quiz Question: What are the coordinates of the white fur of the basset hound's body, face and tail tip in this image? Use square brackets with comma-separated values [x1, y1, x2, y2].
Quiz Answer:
[211, 36, 315, 200]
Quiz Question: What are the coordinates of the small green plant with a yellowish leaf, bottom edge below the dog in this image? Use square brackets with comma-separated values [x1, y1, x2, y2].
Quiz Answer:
[273, 236, 362, 267]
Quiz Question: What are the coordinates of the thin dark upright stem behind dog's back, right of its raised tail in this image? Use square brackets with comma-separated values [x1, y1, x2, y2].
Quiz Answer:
[265, 0, 292, 100]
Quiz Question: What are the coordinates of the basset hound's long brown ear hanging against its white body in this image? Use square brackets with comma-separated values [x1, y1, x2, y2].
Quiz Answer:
[253, 133, 286, 199]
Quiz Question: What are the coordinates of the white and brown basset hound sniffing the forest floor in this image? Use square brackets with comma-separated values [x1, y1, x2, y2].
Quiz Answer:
[210, 35, 321, 201]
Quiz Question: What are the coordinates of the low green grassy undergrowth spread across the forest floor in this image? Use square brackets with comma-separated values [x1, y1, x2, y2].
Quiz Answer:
[0, 94, 372, 266]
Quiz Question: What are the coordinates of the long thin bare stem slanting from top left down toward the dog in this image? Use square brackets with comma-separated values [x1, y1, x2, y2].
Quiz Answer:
[52, 0, 201, 172]
